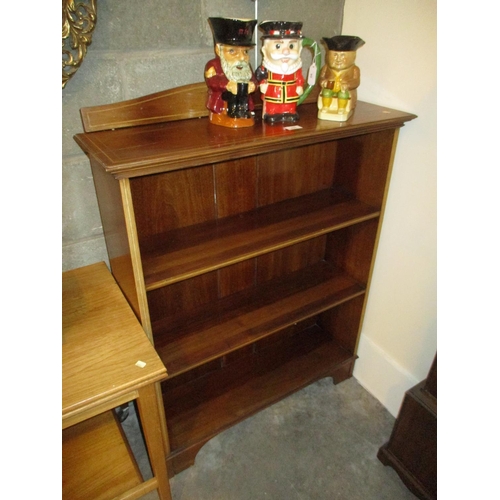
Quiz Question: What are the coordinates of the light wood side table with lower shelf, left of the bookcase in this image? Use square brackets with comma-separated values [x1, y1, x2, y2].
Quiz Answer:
[62, 262, 171, 500]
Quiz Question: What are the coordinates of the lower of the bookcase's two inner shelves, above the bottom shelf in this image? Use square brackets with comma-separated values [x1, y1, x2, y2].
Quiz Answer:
[153, 262, 364, 376]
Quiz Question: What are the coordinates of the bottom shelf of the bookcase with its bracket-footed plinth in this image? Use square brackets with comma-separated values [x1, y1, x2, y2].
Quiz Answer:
[163, 326, 353, 470]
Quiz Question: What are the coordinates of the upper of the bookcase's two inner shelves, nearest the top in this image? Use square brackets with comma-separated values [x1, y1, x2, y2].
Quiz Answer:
[139, 190, 380, 291]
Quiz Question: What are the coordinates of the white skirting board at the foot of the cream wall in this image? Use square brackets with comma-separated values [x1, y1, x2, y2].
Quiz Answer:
[353, 335, 420, 417]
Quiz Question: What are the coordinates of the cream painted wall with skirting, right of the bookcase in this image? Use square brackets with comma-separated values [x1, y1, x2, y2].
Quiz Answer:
[342, 0, 437, 416]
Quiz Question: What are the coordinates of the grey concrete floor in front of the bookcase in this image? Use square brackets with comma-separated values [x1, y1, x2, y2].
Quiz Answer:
[124, 378, 416, 500]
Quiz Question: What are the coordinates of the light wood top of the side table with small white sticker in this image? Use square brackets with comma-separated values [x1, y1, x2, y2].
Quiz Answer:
[62, 262, 167, 427]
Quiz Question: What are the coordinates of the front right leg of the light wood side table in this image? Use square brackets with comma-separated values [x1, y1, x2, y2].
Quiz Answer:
[137, 384, 172, 500]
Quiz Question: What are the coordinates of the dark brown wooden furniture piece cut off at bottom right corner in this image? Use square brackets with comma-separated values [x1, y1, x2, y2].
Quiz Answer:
[378, 356, 437, 500]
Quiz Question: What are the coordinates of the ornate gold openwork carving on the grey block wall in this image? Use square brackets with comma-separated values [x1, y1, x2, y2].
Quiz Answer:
[62, 0, 97, 88]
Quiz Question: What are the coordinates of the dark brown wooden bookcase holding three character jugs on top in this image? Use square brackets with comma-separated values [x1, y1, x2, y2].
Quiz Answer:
[75, 84, 415, 474]
